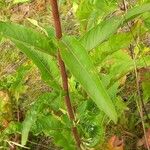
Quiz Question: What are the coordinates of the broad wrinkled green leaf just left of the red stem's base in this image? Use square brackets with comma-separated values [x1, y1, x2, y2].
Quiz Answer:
[33, 114, 75, 150]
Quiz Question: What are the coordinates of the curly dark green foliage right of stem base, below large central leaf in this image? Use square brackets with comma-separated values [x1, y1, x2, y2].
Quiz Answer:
[77, 99, 108, 147]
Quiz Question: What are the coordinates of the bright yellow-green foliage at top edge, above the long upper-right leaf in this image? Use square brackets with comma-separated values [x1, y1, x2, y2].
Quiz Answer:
[76, 0, 116, 32]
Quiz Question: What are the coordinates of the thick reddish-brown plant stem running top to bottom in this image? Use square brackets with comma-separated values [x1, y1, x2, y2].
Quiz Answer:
[50, 0, 81, 149]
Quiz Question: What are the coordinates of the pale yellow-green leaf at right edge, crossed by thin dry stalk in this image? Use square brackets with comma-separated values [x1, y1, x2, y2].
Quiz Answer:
[104, 51, 150, 87]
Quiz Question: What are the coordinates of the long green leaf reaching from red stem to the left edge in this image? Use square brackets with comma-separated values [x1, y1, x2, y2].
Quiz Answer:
[0, 21, 56, 55]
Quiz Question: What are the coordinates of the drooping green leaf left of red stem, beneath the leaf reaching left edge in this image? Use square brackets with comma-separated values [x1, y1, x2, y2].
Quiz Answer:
[13, 40, 60, 89]
